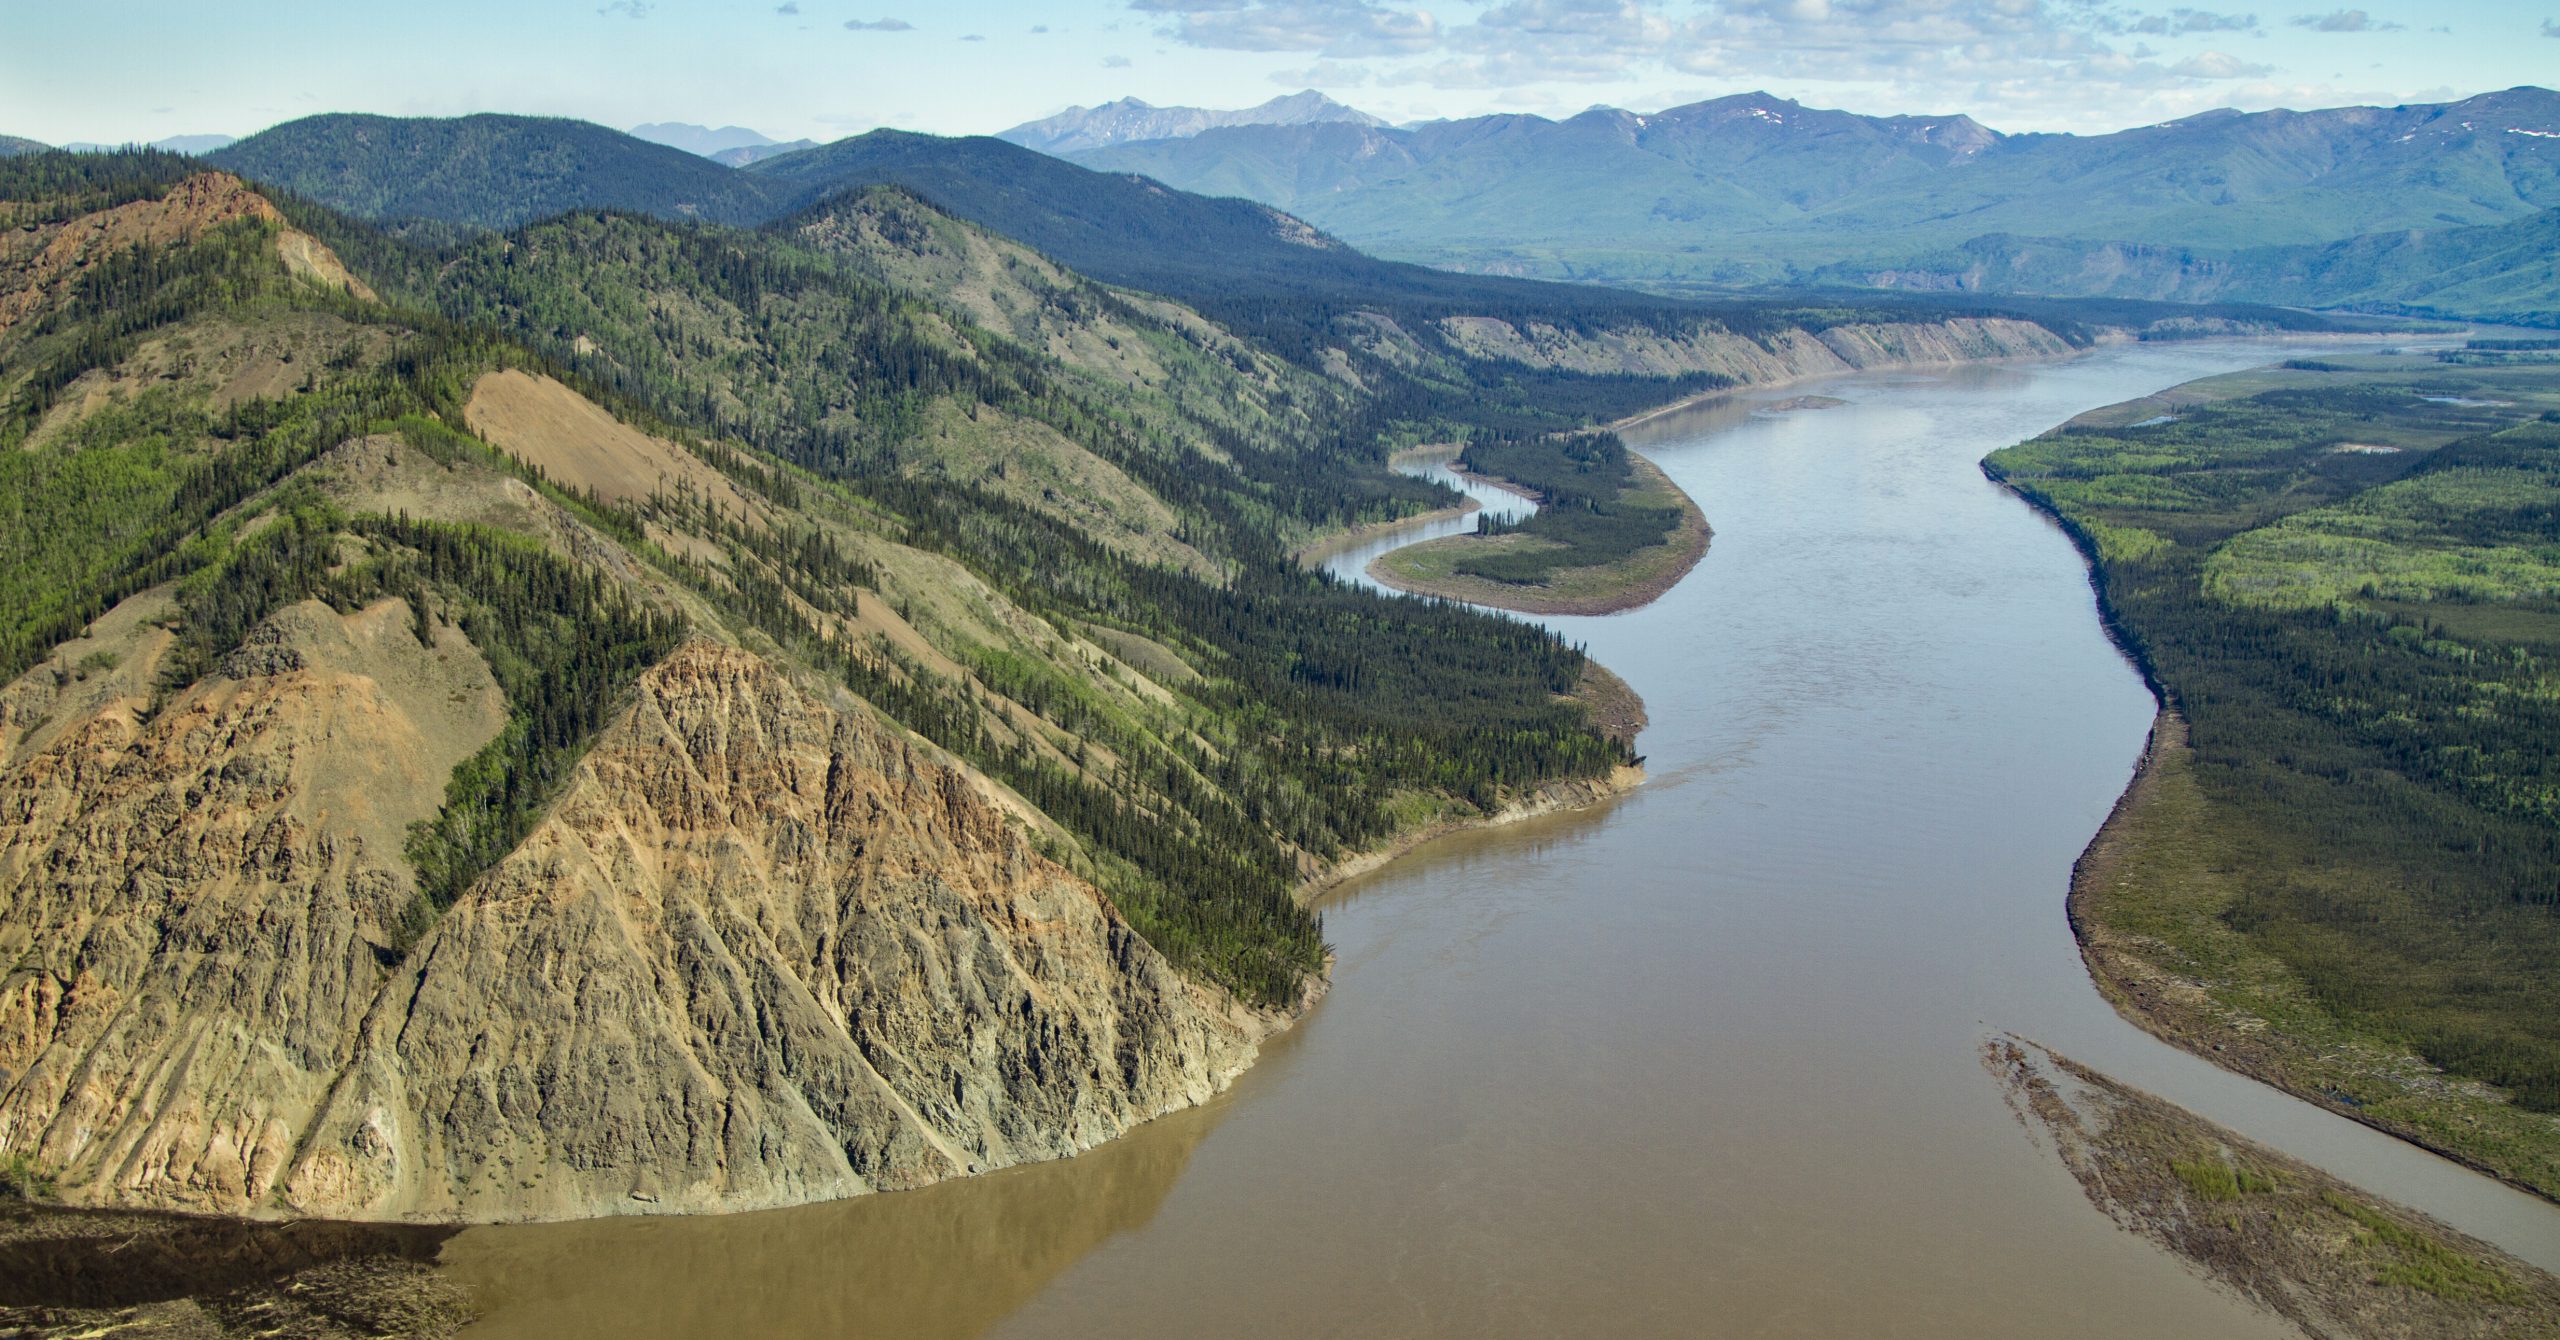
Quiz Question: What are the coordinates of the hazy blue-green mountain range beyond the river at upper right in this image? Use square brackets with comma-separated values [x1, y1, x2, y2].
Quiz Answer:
[1065, 87, 2560, 318]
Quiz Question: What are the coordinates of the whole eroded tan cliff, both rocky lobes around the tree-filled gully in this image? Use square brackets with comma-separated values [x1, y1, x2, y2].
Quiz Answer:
[0, 620, 1267, 1220]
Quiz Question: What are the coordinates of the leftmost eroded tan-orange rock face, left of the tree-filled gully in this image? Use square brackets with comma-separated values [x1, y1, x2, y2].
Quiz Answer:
[0, 602, 504, 1209]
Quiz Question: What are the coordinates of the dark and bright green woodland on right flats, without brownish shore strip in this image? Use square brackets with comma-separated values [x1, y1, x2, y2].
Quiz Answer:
[1987, 354, 2560, 1176]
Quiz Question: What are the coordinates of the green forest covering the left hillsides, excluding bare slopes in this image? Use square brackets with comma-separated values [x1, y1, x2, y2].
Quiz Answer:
[0, 154, 1658, 1004]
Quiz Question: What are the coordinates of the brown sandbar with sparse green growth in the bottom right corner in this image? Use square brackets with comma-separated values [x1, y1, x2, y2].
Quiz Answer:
[1981, 1038, 2560, 1340]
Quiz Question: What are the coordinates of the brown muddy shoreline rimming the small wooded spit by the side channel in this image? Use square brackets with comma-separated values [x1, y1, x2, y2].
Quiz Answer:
[1370, 451, 1715, 615]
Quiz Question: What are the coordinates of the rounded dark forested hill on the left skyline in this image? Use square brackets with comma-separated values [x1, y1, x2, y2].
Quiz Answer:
[205, 113, 771, 228]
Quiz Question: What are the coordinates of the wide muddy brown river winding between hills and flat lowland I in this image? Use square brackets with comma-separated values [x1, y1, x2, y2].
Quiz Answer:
[445, 343, 2560, 1340]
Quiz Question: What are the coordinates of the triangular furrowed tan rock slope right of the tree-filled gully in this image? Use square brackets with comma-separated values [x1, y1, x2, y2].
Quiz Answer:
[287, 643, 1260, 1217]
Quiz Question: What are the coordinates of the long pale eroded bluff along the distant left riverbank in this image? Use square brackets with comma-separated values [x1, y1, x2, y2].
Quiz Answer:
[1441, 318, 2071, 384]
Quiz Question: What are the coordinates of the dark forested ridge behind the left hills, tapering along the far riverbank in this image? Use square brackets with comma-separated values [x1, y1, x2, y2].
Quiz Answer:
[189, 115, 2365, 371]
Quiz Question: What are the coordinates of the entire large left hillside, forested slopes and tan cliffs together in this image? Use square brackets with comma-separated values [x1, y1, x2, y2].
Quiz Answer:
[0, 154, 1633, 1217]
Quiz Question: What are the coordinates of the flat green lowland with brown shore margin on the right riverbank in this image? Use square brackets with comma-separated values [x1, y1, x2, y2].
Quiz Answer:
[1984, 343, 2560, 1197]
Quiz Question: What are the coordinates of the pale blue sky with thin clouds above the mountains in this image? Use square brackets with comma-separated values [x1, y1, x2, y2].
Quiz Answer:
[0, 0, 2560, 143]
